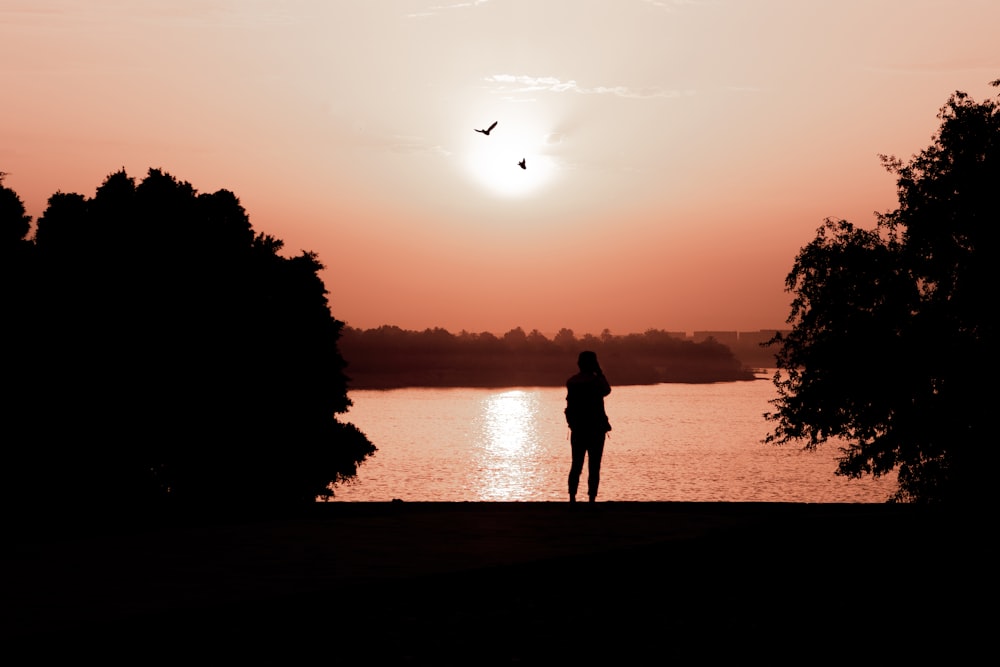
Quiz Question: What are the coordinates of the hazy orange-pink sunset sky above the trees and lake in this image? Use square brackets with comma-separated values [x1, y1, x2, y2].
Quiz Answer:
[0, 0, 1000, 335]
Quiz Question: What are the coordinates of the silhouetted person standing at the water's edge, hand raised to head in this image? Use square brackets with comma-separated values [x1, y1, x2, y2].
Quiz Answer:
[566, 350, 611, 503]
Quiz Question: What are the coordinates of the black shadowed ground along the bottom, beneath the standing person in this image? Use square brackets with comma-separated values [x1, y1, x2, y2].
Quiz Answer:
[0, 503, 997, 665]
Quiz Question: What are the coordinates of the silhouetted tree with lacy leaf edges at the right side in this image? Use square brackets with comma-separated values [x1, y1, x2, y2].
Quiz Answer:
[767, 81, 1000, 503]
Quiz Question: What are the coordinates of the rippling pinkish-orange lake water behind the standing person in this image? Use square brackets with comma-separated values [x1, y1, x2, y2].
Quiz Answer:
[334, 375, 896, 503]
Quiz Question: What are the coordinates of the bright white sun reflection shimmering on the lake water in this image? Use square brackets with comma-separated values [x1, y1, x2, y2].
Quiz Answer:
[473, 390, 539, 500]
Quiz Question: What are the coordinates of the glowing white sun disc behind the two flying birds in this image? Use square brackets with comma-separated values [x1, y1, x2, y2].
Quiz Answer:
[465, 120, 556, 197]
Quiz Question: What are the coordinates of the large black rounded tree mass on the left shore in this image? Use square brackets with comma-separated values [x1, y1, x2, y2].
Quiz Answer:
[0, 169, 375, 512]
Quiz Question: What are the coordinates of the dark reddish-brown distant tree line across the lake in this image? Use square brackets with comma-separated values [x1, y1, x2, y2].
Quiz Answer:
[340, 325, 754, 389]
